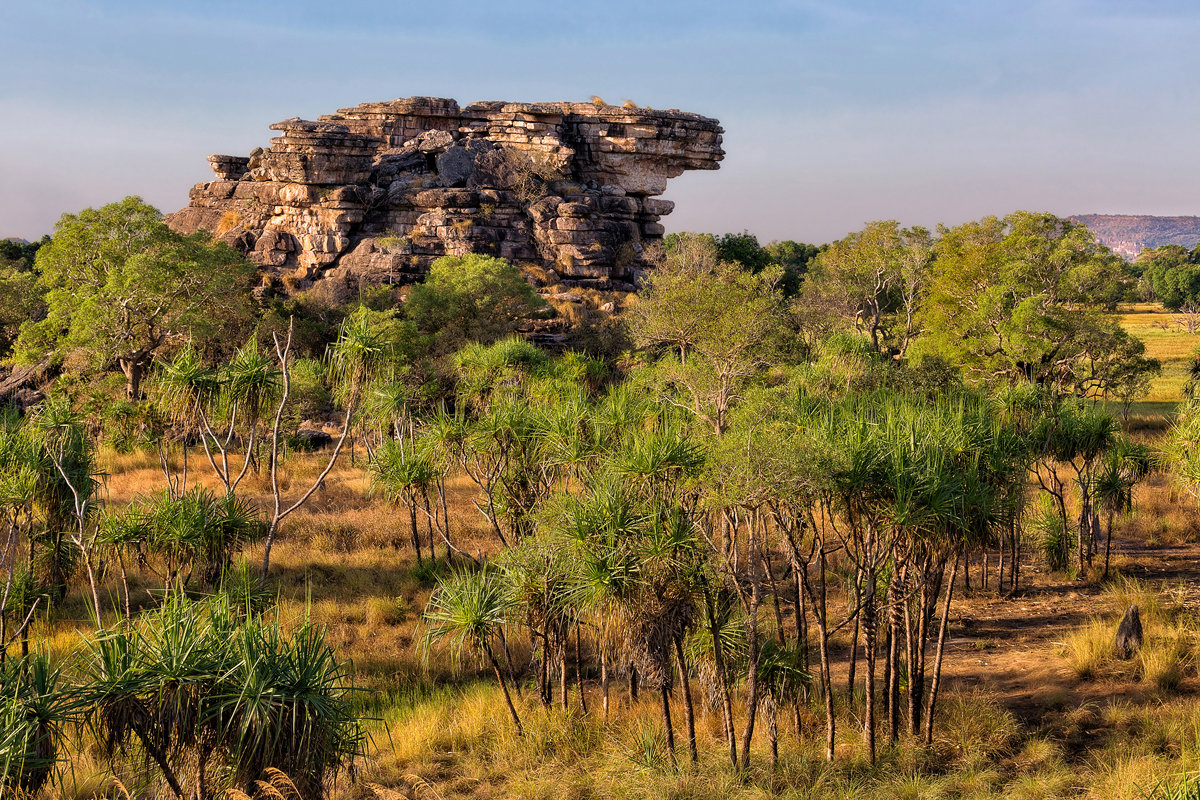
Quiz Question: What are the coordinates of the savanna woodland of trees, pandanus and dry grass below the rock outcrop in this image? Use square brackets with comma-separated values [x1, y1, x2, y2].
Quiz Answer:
[0, 198, 1200, 800]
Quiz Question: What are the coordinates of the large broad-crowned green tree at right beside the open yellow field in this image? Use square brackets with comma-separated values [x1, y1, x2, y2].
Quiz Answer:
[914, 211, 1150, 396]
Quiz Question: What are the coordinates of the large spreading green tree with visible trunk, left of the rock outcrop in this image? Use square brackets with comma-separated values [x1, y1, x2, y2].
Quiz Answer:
[16, 197, 254, 399]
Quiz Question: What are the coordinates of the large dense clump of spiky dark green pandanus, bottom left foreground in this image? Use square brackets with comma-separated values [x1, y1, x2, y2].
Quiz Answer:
[80, 597, 364, 798]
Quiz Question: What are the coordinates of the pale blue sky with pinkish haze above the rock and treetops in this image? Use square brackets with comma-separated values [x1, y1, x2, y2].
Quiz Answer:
[0, 0, 1200, 242]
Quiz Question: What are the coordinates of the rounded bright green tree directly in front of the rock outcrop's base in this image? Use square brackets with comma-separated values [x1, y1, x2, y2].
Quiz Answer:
[404, 253, 546, 353]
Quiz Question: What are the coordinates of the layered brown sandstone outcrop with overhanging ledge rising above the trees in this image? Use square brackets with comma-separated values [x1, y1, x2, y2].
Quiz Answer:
[167, 97, 724, 288]
